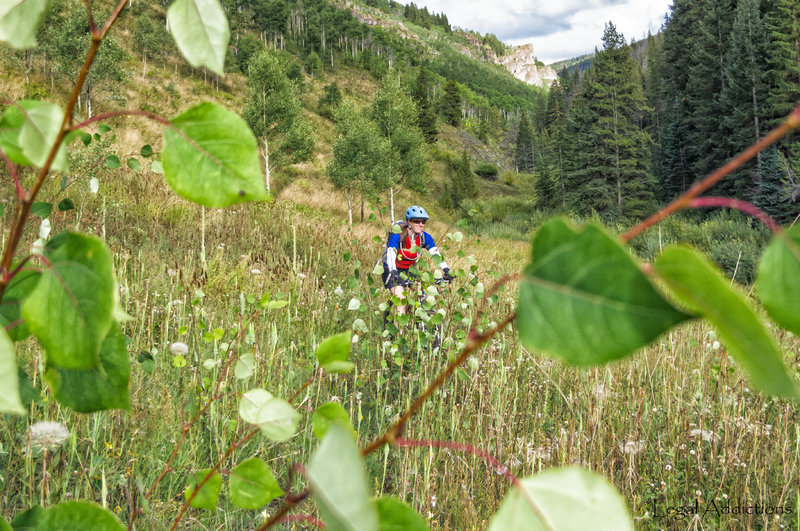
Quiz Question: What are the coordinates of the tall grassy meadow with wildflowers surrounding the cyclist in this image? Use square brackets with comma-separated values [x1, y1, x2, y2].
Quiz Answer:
[0, 156, 800, 530]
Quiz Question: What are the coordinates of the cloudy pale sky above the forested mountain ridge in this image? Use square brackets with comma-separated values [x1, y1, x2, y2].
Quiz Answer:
[404, 0, 672, 64]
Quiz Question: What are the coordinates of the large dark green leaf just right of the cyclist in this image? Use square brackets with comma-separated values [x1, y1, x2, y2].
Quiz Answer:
[517, 218, 689, 365]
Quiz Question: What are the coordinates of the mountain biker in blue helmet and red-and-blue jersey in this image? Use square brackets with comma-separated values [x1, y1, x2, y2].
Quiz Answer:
[381, 205, 452, 315]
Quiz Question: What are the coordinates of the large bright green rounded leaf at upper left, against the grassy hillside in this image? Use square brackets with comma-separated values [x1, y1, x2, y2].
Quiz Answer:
[162, 103, 268, 207]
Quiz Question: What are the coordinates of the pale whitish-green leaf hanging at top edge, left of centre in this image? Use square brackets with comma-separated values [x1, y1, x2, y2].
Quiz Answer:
[167, 0, 231, 76]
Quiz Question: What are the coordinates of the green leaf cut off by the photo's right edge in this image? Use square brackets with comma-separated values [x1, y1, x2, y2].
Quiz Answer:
[756, 225, 800, 335]
